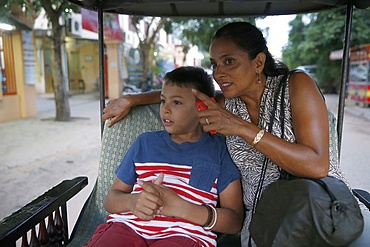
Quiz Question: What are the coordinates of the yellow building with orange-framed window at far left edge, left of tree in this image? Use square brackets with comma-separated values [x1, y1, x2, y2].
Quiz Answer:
[0, 8, 39, 122]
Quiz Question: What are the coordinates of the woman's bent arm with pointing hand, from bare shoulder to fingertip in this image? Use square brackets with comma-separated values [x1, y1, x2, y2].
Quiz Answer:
[195, 72, 329, 177]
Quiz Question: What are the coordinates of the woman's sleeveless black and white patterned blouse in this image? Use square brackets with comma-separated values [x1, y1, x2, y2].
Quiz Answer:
[225, 75, 345, 229]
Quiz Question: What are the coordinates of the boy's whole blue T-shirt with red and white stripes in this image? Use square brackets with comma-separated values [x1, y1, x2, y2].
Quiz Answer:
[108, 131, 240, 246]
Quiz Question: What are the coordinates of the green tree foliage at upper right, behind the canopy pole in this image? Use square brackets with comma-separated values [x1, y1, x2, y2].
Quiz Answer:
[282, 9, 370, 93]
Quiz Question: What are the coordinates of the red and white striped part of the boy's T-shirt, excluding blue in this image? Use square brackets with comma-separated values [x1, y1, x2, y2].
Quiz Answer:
[108, 163, 218, 247]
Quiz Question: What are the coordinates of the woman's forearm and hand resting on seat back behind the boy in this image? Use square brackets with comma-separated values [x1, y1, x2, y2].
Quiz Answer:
[102, 90, 161, 127]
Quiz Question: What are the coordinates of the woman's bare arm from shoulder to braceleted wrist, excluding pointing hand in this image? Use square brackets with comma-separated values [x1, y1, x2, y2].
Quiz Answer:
[250, 73, 330, 178]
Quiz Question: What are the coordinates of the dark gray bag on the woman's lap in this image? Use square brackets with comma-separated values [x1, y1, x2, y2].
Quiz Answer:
[249, 176, 364, 246]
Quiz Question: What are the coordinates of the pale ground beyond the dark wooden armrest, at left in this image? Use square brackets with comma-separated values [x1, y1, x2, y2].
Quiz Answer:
[0, 93, 100, 232]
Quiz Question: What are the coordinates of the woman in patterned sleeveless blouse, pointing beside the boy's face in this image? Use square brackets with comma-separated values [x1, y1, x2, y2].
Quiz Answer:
[103, 22, 358, 245]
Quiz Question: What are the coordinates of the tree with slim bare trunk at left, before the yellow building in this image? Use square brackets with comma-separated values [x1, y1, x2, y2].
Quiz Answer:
[1, 0, 76, 121]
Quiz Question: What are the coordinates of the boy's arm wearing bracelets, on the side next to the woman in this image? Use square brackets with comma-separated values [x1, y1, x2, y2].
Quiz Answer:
[141, 180, 244, 234]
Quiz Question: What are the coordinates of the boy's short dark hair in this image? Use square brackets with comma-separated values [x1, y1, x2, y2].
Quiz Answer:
[164, 66, 215, 97]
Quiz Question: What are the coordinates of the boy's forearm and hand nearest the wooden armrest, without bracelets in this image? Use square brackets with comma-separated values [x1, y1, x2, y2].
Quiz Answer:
[104, 178, 162, 220]
